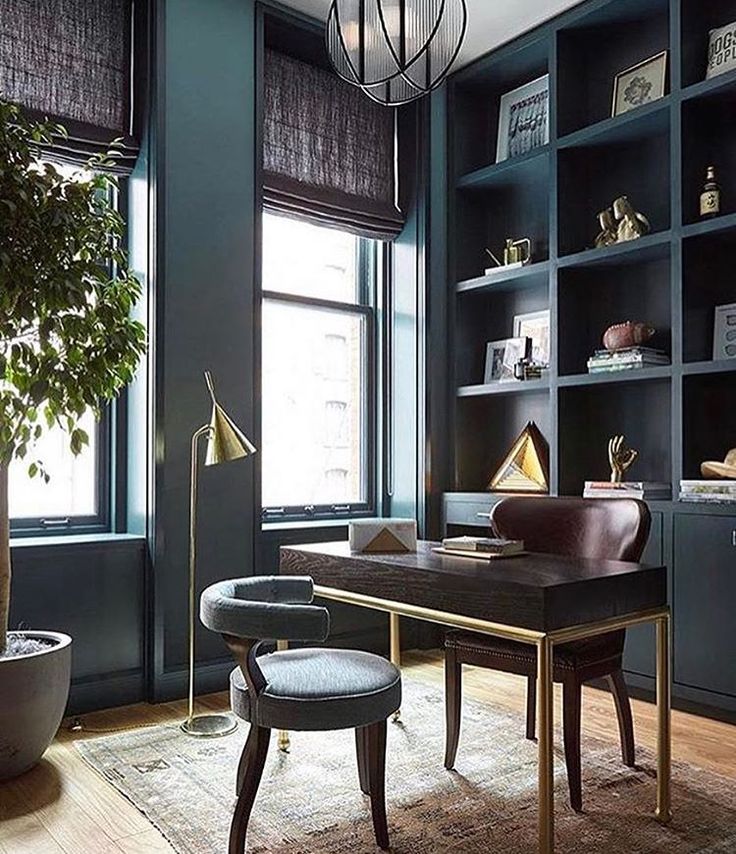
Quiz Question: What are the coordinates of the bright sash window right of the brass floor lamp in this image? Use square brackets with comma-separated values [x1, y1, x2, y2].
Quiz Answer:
[261, 213, 379, 518]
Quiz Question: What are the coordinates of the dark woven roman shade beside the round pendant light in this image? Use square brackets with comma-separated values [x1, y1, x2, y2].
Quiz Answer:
[263, 50, 403, 240]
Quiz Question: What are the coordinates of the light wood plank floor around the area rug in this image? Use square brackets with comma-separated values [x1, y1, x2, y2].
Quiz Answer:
[0, 651, 736, 854]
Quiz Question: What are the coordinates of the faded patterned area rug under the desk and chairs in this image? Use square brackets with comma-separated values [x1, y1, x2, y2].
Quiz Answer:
[77, 679, 736, 854]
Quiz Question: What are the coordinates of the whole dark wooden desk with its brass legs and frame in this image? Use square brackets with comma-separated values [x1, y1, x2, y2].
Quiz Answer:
[280, 542, 671, 854]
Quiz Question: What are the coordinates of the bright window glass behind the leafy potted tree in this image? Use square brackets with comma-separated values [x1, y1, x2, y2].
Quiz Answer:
[8, 162, 109, 533]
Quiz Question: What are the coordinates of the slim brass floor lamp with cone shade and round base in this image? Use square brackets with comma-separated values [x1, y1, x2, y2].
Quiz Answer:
[181, 371, 256, 738]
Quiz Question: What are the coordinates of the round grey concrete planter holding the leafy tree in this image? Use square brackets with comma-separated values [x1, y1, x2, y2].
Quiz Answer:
[0, 631, 72, 780]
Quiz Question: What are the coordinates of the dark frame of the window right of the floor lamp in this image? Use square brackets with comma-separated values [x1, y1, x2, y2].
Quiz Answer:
[259, 231, 382, 522]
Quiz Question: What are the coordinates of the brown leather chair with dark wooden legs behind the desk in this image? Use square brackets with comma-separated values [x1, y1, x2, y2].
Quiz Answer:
[445, 496, 651, 811]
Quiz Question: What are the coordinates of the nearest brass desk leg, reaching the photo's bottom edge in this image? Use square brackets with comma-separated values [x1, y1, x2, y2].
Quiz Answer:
[537, 637, 555, 854]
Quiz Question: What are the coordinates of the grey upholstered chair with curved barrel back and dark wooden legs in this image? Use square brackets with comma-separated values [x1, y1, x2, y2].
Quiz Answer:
[200, 576, 401, 854]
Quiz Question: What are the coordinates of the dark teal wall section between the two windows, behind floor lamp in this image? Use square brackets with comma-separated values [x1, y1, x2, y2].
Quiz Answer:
[153, 0, 256, 698]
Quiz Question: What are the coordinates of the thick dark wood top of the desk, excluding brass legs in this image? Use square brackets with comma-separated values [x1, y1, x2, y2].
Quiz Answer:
[280, 541, 667, 631]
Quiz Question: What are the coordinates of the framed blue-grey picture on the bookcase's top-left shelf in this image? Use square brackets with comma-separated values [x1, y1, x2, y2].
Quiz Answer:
[496, 74, 549, 163]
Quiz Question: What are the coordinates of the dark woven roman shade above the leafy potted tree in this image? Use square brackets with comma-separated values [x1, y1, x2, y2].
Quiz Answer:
[0, 0, 137, 171]
